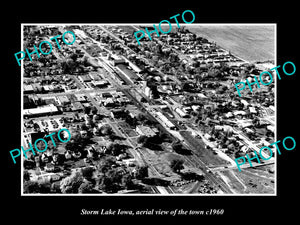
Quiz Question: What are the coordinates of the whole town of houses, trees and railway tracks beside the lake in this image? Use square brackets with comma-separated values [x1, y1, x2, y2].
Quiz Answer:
[22, 24, 276, 195]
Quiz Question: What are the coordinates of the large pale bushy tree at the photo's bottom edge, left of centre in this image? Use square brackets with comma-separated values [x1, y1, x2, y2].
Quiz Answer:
[60, 172, 83, 194]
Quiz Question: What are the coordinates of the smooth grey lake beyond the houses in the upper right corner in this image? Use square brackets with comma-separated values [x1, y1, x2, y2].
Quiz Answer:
[186, 25, 275, 62]
